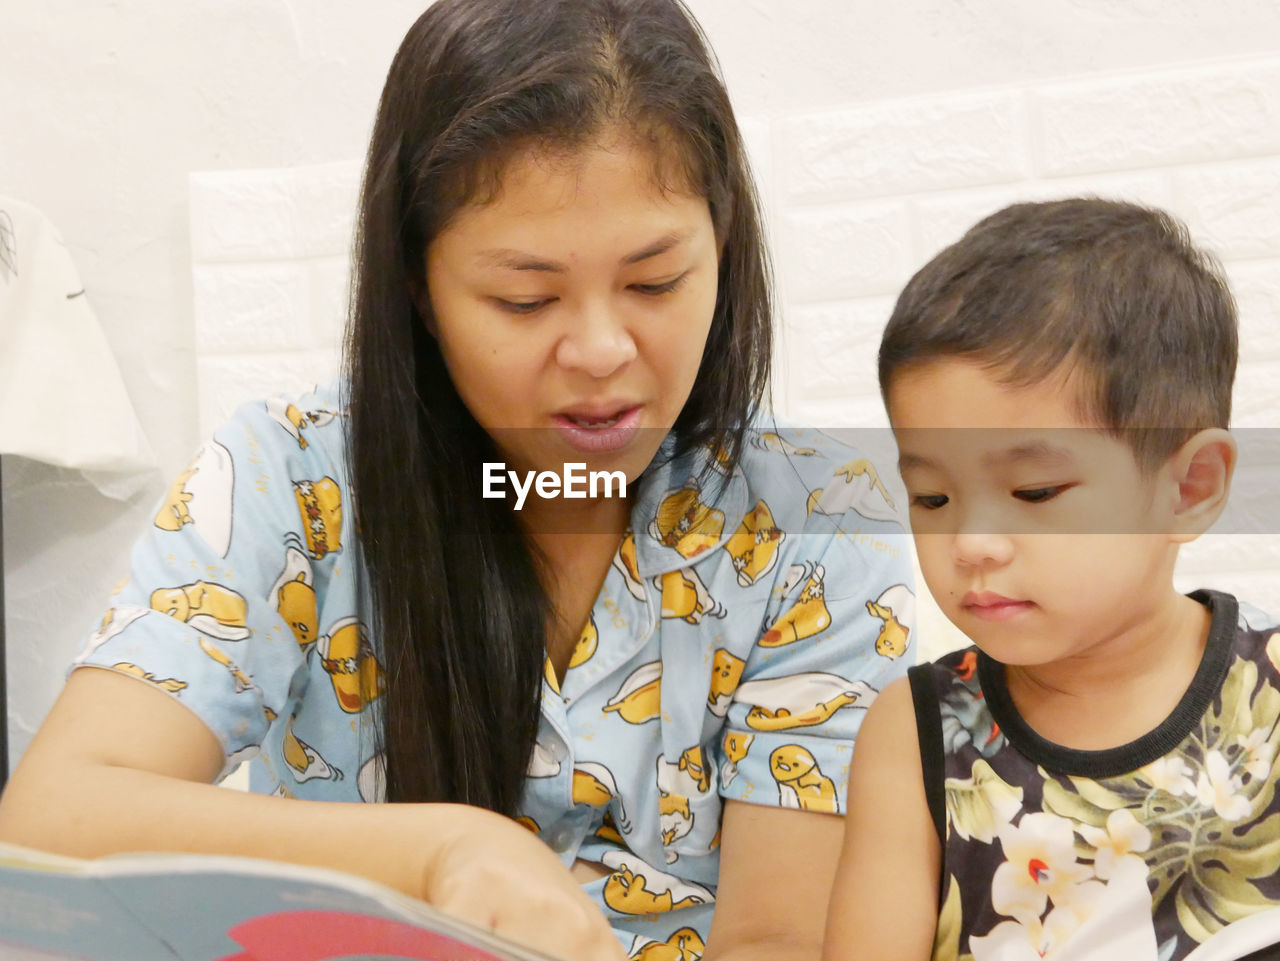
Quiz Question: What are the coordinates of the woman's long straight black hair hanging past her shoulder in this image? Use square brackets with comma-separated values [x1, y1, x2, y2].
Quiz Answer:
[347, 0, 772, 814]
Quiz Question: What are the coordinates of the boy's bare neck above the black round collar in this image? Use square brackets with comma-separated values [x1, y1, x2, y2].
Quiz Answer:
[1005, 589, 1211, 751]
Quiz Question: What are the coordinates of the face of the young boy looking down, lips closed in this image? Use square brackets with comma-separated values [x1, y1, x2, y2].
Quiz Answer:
[888, 358, 1176, 665]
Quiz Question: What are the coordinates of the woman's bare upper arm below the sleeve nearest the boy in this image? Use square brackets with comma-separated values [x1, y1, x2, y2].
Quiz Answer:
[704, 801, 844, 961]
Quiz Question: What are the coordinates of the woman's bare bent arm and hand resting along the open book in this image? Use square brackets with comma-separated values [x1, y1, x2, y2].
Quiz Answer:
[0, 668, 622, 961]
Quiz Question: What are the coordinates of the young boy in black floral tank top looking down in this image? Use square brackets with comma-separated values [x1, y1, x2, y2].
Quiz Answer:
[824, 200, 1280, 961]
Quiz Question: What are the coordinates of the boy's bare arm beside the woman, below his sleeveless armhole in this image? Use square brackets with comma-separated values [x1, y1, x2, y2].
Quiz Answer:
[822, 678, 942, 961]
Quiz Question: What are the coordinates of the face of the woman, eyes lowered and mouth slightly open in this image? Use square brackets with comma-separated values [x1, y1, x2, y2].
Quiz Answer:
[426, 132, 719, 491]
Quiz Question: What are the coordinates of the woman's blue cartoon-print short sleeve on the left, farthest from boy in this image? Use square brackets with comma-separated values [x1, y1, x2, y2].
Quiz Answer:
[73, 392, 351, 774]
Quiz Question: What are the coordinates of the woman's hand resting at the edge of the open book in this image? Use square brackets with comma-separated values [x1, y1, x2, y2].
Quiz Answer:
[420, 805, 626, 961]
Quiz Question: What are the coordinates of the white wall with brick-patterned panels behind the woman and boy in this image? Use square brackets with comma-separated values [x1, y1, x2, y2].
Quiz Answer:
[0, 0, 1280, 767]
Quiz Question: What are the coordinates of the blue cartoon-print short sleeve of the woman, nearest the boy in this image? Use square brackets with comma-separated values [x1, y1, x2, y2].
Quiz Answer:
[717, 432, 915, 814]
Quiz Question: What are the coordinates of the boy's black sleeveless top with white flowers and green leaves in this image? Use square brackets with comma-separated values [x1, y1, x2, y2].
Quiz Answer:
[911, 591, 1280, 961]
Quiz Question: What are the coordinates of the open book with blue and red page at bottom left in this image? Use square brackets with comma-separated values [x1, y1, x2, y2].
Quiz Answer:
[0, 845, 560, 961]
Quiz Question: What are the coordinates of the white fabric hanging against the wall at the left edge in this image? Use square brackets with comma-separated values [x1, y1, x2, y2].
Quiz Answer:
[0, 197, 155, 483]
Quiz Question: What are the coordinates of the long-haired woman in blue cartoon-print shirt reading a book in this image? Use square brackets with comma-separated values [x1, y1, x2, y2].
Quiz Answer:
[0, 0, 910, 958]
